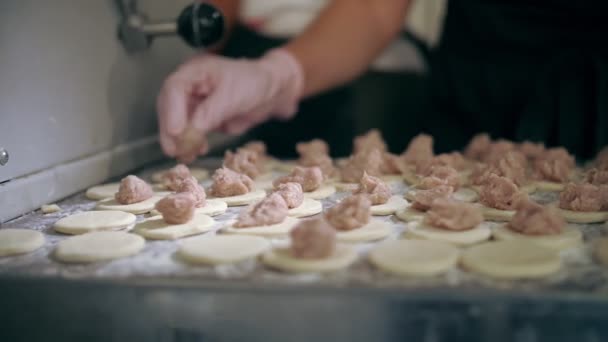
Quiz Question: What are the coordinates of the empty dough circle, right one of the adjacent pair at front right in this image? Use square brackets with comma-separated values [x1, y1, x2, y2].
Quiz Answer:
[461, 240, 561, 279]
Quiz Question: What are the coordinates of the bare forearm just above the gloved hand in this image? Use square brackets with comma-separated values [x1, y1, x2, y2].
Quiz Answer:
[286, 0, 411, 96]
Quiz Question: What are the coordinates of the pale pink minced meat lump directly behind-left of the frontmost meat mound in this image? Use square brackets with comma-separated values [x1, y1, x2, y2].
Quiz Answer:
[234, 193, 289, 228]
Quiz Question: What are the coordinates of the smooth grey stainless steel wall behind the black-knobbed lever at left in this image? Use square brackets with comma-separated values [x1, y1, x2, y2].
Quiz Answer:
[0, 0, 193, 183]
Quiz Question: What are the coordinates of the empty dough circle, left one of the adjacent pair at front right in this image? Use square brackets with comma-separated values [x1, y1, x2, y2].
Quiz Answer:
[368, 240, 460, 276]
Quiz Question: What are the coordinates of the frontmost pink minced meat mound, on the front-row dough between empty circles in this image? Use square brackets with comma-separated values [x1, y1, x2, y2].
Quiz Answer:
[289, 218, 336, 259]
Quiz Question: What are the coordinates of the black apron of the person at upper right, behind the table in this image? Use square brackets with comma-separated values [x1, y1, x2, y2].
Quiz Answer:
[423, 0, 608, 158]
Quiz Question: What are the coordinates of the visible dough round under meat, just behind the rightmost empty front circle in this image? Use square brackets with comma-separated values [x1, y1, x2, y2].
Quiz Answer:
[492, 225, 583, 250]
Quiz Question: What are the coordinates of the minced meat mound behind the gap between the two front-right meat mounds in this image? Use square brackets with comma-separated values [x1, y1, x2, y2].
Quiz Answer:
[479, 174, 527, 210]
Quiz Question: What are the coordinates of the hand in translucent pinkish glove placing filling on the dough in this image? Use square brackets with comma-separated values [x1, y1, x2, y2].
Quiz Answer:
[157, 49, 304, 160]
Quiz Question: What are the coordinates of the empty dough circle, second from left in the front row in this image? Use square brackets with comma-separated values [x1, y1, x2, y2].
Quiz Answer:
[55, 232, 145, 262]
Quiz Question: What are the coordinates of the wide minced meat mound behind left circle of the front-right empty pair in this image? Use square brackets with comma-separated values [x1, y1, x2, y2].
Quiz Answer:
[424, 198, 483, 231]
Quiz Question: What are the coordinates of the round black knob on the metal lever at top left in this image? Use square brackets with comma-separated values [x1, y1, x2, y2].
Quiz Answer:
[177, 2, 225, 48]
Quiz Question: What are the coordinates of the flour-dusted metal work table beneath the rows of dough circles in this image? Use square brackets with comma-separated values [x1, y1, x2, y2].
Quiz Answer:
[0, 160, 608, 341]
